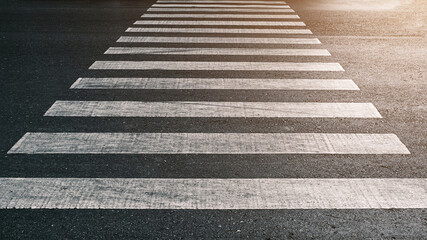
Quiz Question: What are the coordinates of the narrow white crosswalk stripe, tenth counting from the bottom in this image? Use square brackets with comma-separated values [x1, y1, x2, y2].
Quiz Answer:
[141, 13, 299, 20]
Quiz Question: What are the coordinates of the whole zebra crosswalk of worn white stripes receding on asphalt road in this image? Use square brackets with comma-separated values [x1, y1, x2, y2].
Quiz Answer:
[0, 0, 427, 210]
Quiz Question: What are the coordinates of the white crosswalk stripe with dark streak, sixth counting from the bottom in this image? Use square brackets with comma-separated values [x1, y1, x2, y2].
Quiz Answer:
[105, 47, 331, 56]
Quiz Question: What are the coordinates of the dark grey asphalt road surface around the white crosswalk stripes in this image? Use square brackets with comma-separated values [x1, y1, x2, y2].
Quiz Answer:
[0, 0, 427, 239]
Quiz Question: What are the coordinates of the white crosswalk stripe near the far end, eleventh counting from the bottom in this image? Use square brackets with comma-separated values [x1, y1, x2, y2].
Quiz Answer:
[147, 8, 295, 13]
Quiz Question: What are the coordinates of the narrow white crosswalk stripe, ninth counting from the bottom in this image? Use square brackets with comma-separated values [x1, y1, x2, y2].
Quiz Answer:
[134, 20, 305, 27]
